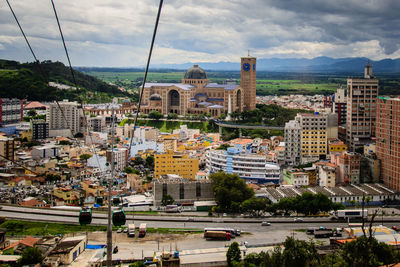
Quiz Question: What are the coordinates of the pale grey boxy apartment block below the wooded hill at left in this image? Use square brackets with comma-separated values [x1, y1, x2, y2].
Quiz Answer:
[46, 100, 82, 136]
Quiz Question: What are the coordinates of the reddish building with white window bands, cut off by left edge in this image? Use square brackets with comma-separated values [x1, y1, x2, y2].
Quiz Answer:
[0, 98, 24, 127]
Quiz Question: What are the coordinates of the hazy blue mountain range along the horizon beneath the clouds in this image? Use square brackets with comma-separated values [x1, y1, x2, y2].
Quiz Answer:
[152, 57, 400, 73]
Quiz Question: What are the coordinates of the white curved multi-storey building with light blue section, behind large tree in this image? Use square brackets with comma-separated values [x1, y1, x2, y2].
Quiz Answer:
[206, 147, 281, 184]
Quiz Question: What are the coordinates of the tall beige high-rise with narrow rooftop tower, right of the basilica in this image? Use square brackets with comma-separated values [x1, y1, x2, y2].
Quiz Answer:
[346, 63, 379, 151]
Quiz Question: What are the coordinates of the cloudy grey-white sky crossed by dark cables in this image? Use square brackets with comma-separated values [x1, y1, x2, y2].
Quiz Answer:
[0, 0, 400, 67]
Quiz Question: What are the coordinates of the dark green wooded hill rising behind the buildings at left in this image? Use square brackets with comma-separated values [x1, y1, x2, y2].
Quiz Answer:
[0, 60, 131, 102]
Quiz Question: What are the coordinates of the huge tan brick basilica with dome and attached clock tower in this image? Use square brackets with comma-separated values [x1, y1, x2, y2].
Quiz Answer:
[140, 56, 256, 116]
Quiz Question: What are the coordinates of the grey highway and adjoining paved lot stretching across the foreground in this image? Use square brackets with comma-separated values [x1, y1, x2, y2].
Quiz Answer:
[0, 206, 400, 249]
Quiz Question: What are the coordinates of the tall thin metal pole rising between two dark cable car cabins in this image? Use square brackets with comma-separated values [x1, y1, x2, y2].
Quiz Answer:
[107, 107, 114, 267]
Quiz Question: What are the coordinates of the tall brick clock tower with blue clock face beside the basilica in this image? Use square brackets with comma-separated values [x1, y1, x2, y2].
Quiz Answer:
[240, 54, 256, 110]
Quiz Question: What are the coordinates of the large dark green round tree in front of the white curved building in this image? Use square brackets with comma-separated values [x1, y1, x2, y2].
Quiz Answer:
[210, 172, 254, 212]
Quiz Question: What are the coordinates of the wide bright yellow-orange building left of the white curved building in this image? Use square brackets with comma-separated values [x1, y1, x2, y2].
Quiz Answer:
[154, 151, 199, 180]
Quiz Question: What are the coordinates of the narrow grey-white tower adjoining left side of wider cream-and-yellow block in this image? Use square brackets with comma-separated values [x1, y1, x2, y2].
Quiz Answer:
[285, 120, 301, 165]
